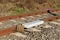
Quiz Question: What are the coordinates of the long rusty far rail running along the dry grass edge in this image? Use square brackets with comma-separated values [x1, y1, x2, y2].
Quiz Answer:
[0, 9, 60, 21]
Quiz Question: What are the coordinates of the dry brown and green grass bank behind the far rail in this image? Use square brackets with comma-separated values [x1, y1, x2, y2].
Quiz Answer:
[0, 0, 60, 17]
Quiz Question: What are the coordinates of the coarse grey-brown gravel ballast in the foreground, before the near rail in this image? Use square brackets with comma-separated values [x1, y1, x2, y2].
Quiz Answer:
[0, 19, 60, 40]
